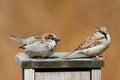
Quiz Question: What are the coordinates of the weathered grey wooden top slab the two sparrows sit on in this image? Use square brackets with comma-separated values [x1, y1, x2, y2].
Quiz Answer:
[16, 52, 104, 68]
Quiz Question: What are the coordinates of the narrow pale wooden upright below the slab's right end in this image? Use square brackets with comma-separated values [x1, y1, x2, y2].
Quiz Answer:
[91, 69, 101, 80]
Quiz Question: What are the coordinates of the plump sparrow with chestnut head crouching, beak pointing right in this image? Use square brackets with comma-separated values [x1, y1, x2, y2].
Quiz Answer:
[8, 33, 60, 58]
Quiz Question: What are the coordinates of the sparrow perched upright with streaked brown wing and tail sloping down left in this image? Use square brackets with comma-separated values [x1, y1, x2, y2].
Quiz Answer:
[64, 26, 110, 59]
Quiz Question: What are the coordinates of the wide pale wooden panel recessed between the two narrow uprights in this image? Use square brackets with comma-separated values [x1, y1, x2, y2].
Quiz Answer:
[35, 71, 90, 80]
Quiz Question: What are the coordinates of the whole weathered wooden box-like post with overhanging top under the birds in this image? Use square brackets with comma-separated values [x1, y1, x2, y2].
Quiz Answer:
[16, 52, 104, 80]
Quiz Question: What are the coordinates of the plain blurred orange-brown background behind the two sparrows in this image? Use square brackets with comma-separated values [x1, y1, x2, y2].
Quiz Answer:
[0, 0, 120, 80]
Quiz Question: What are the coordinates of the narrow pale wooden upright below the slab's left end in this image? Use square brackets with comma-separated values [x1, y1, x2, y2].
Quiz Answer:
[23, 69, 35, 80]
